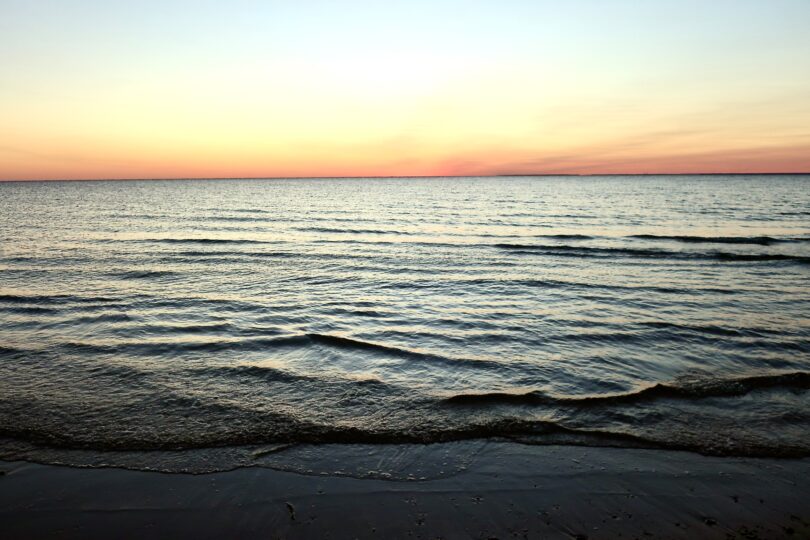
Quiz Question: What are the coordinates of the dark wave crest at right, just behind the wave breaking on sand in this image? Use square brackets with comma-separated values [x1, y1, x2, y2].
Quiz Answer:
[443, 371, 810, 407]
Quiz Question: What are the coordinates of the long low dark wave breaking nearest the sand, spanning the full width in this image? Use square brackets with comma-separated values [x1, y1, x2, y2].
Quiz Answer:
[0, 410, 808, 460]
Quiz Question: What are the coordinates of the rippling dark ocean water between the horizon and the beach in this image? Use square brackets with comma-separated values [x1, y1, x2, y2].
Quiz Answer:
[0, 176, 810, 468]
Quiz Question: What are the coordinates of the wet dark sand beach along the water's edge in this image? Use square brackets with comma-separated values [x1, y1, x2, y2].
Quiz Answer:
[0, 442, 810, 539]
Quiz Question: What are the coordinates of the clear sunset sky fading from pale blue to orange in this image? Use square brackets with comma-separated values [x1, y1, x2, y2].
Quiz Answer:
[0, 0, 810, 180]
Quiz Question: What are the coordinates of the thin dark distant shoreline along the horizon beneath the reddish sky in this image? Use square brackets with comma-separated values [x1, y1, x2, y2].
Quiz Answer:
[0, 171, 810, 183]
